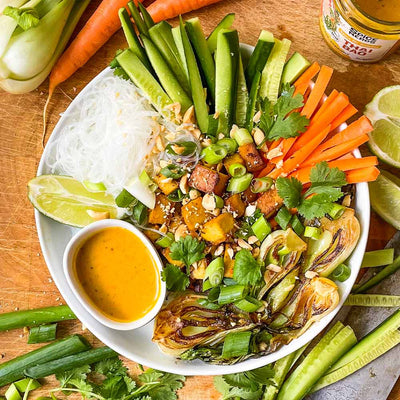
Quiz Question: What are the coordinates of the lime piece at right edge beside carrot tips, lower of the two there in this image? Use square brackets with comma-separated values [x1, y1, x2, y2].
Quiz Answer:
[369, 171, 400, 229]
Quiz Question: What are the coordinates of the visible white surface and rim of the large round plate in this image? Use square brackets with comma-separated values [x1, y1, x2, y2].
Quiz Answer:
[35, 46, 370, 375]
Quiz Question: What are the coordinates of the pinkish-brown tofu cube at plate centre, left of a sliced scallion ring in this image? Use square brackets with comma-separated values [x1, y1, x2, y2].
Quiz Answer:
[189, 164, 229, 195]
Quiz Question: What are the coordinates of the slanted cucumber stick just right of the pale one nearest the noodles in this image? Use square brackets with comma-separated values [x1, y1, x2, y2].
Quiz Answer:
[142, 36, 192, 113]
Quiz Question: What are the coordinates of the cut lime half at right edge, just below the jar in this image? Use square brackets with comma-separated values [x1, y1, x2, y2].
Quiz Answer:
[364, 85, 400, 168]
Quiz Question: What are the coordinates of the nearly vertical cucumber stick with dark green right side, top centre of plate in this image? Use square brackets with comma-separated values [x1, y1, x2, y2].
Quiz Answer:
[215, 29, 239, 136]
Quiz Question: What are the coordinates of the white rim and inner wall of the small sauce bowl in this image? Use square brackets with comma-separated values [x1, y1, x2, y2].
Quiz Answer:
[63, 219, 166, 331]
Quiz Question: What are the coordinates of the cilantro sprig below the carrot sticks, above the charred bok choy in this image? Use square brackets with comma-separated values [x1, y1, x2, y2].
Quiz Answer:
[276, 161, 347, 219]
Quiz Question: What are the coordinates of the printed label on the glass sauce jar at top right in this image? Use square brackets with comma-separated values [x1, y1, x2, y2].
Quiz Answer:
[321, 0, 397, 62]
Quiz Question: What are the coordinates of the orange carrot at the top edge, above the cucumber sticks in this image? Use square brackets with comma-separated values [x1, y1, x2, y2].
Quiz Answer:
[147, 0, 220, 22]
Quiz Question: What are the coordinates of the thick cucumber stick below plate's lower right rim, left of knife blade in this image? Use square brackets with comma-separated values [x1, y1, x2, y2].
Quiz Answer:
[277, 322, 357, 400]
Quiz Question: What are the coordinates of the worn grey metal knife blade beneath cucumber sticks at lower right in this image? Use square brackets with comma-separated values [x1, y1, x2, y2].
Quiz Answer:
[310, 231, 400, 400]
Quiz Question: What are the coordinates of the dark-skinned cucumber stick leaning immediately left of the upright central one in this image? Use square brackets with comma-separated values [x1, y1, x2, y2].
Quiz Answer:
[185, 18, 215, 101]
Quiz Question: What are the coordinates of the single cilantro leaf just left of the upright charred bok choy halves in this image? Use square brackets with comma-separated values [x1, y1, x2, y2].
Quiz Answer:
[233, 249, 262, 285]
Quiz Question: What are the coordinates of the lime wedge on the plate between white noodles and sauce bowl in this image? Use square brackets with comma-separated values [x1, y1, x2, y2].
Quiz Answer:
[28, 175, 122, 227]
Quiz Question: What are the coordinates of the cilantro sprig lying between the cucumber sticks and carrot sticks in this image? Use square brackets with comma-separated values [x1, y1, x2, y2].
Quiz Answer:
[258, 84, 310, 141]
